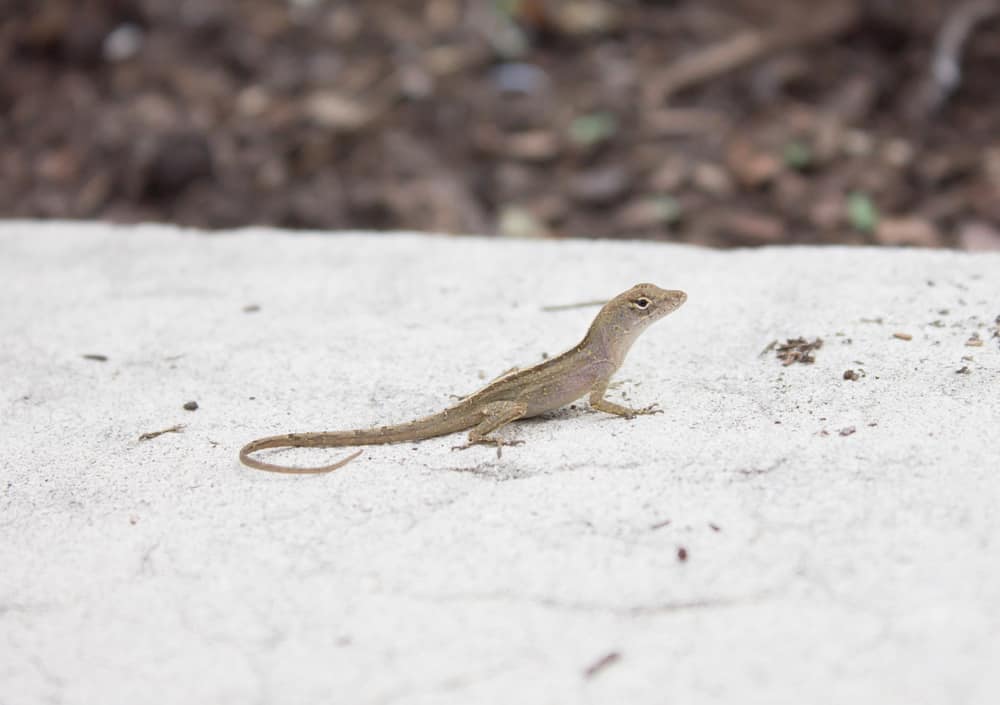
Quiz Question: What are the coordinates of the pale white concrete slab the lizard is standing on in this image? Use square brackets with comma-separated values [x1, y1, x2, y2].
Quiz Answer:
[0, 223, 1000, 705]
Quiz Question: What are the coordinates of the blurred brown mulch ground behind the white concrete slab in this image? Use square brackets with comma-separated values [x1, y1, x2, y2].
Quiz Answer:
[0, 0, 1000, 250]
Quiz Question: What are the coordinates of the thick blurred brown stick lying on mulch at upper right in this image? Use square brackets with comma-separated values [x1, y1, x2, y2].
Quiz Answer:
[646, 2, 861, 106]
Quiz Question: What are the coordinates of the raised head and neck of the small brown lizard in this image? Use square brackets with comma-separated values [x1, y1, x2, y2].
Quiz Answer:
[585, 284, 687, 366]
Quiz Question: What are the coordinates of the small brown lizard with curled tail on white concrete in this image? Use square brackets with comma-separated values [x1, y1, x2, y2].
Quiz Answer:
[239, 284, 687, 474]
